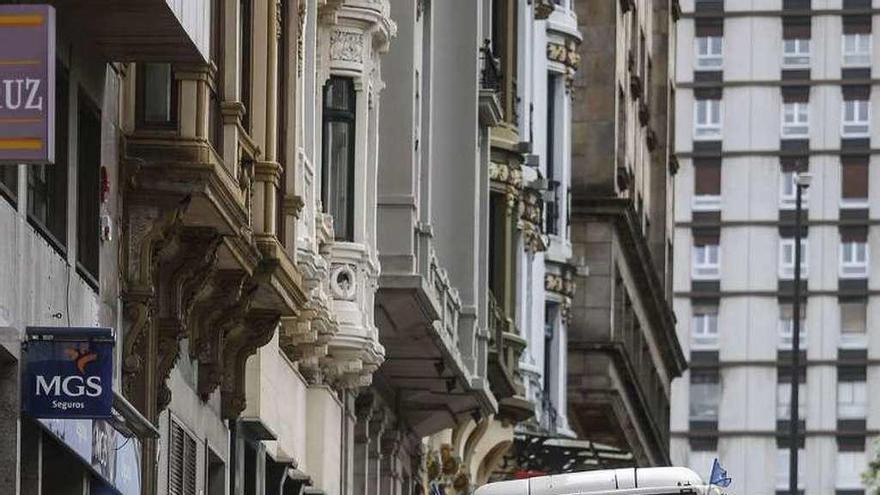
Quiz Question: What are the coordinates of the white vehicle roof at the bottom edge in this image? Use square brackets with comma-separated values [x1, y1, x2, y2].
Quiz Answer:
[474, 467, 726, 495]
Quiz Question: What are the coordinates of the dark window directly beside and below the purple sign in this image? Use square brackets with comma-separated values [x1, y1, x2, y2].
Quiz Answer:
[26, 64, 70, 250]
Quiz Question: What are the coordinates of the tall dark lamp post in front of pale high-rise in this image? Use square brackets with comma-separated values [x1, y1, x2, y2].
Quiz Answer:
[788, 173, 813, 495]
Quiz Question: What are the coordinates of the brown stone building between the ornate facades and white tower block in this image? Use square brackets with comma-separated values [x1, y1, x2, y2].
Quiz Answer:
[567, 0, 685, 466]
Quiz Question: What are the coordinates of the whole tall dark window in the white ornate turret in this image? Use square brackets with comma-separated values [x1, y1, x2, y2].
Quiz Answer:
[321, 76, 356, 241]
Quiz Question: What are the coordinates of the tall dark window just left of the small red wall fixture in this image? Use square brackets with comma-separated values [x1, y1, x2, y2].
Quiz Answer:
[76, 92, 101, 287]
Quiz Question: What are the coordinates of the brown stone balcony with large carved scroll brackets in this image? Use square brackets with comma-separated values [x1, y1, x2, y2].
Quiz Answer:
[122, 66, 306, 421]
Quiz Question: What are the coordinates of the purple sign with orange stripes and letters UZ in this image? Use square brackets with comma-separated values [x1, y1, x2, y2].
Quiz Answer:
[0, 5, 55, 163]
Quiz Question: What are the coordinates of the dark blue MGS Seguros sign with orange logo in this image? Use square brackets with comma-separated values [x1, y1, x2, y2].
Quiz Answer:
[21, 327, 114, 419]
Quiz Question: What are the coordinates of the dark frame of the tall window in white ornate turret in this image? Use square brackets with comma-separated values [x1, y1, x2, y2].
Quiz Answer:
[321, 76, 358, 242]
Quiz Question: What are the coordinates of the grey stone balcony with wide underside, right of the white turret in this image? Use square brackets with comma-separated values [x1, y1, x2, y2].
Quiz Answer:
[376, 227, 492, 436]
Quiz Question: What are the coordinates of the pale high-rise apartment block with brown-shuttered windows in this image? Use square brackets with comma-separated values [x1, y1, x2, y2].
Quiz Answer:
[671, 0, 880, 495]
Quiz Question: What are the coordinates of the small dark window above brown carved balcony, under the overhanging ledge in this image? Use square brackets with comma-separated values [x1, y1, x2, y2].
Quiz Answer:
[137, 63, 177, 128]
